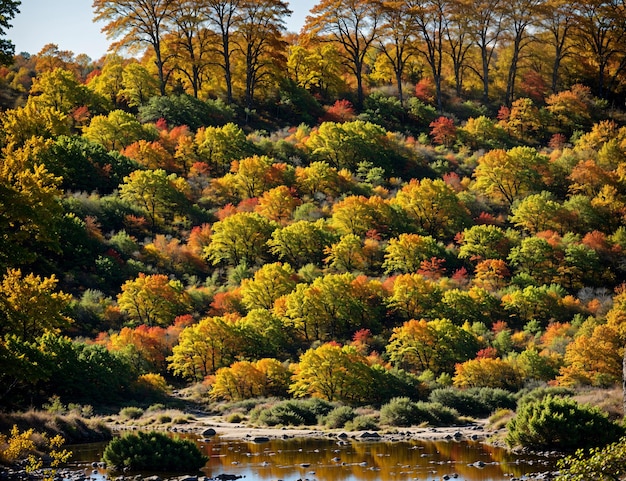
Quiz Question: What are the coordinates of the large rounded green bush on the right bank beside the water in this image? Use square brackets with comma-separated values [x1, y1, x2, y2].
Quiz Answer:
[506, 395, 624, 451]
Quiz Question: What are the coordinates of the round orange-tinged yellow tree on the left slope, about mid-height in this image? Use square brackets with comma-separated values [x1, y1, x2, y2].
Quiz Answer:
[117, 273, 191, 327]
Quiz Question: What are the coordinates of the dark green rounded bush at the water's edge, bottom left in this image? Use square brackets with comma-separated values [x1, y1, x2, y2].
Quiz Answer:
[103, 431, 208, 473]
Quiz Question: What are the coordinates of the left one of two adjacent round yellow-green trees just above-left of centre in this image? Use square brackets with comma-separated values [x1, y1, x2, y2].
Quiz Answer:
[204, 212, 276, 266]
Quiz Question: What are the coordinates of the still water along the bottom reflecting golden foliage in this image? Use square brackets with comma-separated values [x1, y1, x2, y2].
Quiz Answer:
[71, 436, 556, 481]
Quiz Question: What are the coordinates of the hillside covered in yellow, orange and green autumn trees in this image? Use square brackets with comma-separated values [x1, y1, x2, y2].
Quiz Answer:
[0, 0, 626, 416]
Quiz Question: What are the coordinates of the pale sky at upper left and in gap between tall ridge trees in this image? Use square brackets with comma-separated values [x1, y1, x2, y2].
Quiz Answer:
[7, 0, 317, 60]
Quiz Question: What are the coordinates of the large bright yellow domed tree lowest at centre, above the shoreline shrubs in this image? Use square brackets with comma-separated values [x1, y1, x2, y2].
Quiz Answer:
[289, 343, 373, 404]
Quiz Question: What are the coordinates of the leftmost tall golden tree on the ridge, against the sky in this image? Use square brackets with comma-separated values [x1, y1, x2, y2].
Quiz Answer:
[93, 0, 178, 95]
